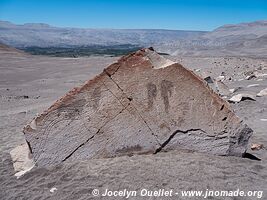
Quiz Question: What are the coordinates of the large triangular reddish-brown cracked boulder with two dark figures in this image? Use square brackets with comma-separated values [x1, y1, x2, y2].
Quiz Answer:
[24, 48, 252, 166]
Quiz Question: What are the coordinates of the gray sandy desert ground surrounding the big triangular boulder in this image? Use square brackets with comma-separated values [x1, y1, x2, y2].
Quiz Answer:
[0, 48, 267, 200]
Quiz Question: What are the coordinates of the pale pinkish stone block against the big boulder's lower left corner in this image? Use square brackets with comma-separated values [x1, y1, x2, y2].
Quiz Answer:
[10, 143, 34, 178]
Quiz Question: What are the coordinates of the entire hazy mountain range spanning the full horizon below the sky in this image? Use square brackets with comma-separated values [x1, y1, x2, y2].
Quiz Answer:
[0, 21, 267, 57]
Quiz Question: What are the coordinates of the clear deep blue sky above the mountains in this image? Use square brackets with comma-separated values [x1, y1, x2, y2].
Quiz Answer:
[0, 0, 267, 30]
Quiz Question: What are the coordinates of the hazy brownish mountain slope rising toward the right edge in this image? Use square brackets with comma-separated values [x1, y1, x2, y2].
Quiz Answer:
[161, 21, 267, 57]
